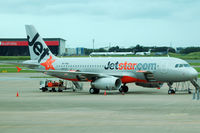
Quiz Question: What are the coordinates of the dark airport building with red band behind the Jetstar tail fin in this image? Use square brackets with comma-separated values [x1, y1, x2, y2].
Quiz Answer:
[0, 38, 65, 56]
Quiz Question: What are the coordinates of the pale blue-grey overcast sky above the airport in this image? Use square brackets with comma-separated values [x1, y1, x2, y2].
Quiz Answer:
[0, 0, 200, 48]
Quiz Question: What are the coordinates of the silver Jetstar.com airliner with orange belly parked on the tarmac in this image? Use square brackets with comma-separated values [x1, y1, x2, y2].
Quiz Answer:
[7, 25, 198, 94]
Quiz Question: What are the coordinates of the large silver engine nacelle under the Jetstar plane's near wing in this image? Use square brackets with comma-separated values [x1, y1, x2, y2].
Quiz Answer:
[91, 77, 122, 90]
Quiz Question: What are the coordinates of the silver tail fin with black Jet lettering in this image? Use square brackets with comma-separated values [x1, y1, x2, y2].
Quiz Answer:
[25, 25, 56, 63]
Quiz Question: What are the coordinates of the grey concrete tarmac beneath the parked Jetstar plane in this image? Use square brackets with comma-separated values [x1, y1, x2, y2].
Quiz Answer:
[0, 73, 200, 133]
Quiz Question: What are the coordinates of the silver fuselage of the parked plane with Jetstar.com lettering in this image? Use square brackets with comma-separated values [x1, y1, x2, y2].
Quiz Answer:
[32, 57, 197, 83]
